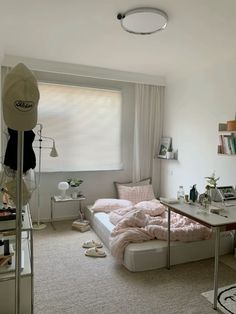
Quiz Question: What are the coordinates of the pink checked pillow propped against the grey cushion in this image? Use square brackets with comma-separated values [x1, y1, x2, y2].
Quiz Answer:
[118, 184, 155, 204]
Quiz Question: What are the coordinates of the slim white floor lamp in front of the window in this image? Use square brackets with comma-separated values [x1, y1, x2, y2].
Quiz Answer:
[33, 123, 58, 230]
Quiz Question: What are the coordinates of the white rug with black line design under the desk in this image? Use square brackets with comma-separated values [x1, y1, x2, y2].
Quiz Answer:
[202, 284, 236, 314]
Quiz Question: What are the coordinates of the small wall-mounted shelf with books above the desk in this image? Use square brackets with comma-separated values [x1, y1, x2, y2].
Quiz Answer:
[217, 123, 236, 157]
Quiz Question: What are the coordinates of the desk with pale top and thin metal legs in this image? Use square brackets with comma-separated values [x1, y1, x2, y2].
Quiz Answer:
[161, 201, 236, 310]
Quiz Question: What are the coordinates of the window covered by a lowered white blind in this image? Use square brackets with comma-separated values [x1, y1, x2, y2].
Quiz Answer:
[35, 83, 122, 172]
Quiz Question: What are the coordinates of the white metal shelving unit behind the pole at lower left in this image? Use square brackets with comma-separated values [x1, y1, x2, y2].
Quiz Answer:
[0, 205, 33, 314]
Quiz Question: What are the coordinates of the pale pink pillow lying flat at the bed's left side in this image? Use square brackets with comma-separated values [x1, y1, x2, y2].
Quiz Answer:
[92, 198, 133, 213]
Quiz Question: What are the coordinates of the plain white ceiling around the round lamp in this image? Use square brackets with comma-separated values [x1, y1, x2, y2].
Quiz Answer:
[0, 0, 236, 76]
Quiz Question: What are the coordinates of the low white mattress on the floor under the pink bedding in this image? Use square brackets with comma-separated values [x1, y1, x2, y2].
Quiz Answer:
[85, 206, 234, 272]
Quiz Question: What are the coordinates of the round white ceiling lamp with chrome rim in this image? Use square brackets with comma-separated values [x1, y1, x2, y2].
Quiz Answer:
[117, 8, 168, 35]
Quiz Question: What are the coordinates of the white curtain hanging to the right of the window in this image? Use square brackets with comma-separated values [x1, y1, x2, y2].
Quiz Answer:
[133, 84, 164, 195]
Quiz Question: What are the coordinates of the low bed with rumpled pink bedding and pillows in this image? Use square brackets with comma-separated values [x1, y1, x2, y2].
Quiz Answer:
[85, 178, 234, 272]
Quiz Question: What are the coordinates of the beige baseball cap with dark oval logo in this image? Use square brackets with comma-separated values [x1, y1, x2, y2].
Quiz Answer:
[2, 63, 39, 131]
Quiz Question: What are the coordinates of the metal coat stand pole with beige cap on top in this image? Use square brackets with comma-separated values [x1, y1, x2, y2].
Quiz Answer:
[2, 63, 40, 314]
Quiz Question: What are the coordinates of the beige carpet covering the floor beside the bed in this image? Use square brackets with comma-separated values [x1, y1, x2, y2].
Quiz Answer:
[34, 222, 236, 314]
